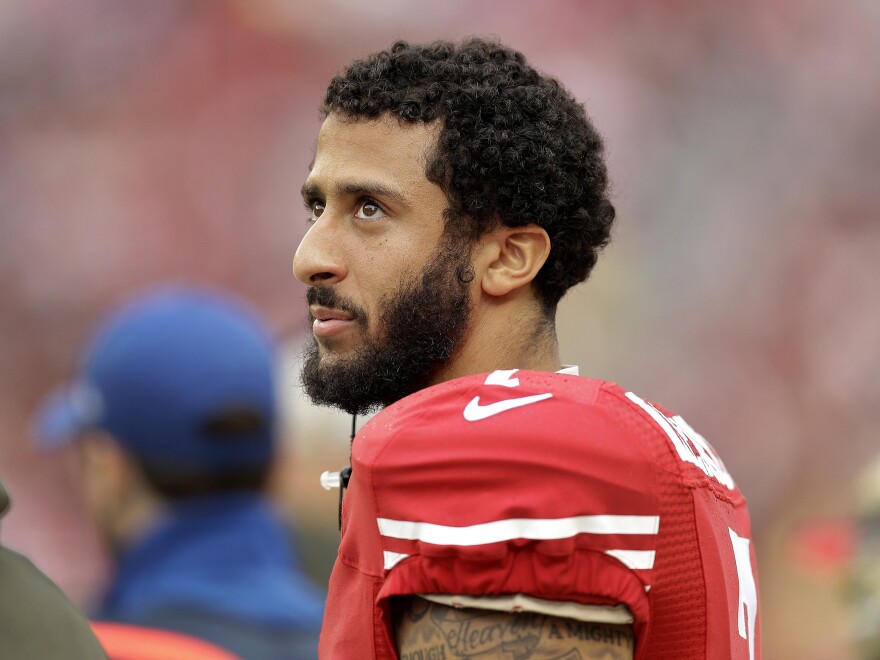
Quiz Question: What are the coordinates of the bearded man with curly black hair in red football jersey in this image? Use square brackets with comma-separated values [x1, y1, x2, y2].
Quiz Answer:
[293, 40, 760, 660]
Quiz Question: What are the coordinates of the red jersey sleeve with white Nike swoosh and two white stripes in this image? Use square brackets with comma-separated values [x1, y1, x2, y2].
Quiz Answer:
[343, 372, 659, 634]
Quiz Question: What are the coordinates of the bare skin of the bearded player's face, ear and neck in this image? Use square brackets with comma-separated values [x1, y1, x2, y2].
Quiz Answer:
[293, 114, 560, 384]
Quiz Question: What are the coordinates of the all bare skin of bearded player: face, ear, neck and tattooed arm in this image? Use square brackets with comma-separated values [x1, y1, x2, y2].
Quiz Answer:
[293, 114, 633, 660]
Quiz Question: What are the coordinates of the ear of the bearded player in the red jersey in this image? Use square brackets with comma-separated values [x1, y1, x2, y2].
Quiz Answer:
[480, 225, 550, 296]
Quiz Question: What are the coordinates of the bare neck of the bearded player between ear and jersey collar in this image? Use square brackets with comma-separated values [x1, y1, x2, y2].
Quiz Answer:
[431, 292, 562, 385]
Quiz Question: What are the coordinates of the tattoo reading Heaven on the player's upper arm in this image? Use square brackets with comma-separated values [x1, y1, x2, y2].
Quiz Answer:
[431, 608, 547, 660]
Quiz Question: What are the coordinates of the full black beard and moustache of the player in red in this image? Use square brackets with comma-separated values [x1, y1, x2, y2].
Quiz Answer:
[301, 237, 474, 415]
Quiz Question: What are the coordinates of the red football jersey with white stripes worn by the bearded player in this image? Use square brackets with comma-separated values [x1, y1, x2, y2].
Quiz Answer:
[320, 370, 760, 660]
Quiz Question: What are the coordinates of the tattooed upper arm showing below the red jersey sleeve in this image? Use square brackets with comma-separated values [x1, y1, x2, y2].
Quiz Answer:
[395, 597, 634, 660]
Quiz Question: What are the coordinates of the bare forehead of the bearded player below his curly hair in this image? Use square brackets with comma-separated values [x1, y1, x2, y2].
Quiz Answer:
[308, 113, 439, 192]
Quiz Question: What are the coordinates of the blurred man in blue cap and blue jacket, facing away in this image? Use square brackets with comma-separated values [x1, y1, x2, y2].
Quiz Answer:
[41, 287, 323, 660]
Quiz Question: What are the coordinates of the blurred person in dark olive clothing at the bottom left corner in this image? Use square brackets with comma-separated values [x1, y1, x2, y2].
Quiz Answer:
[0, 483, 106, 660]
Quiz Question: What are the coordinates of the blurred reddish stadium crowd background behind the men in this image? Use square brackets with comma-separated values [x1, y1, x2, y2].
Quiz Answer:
[0, 0, 880, 659]
